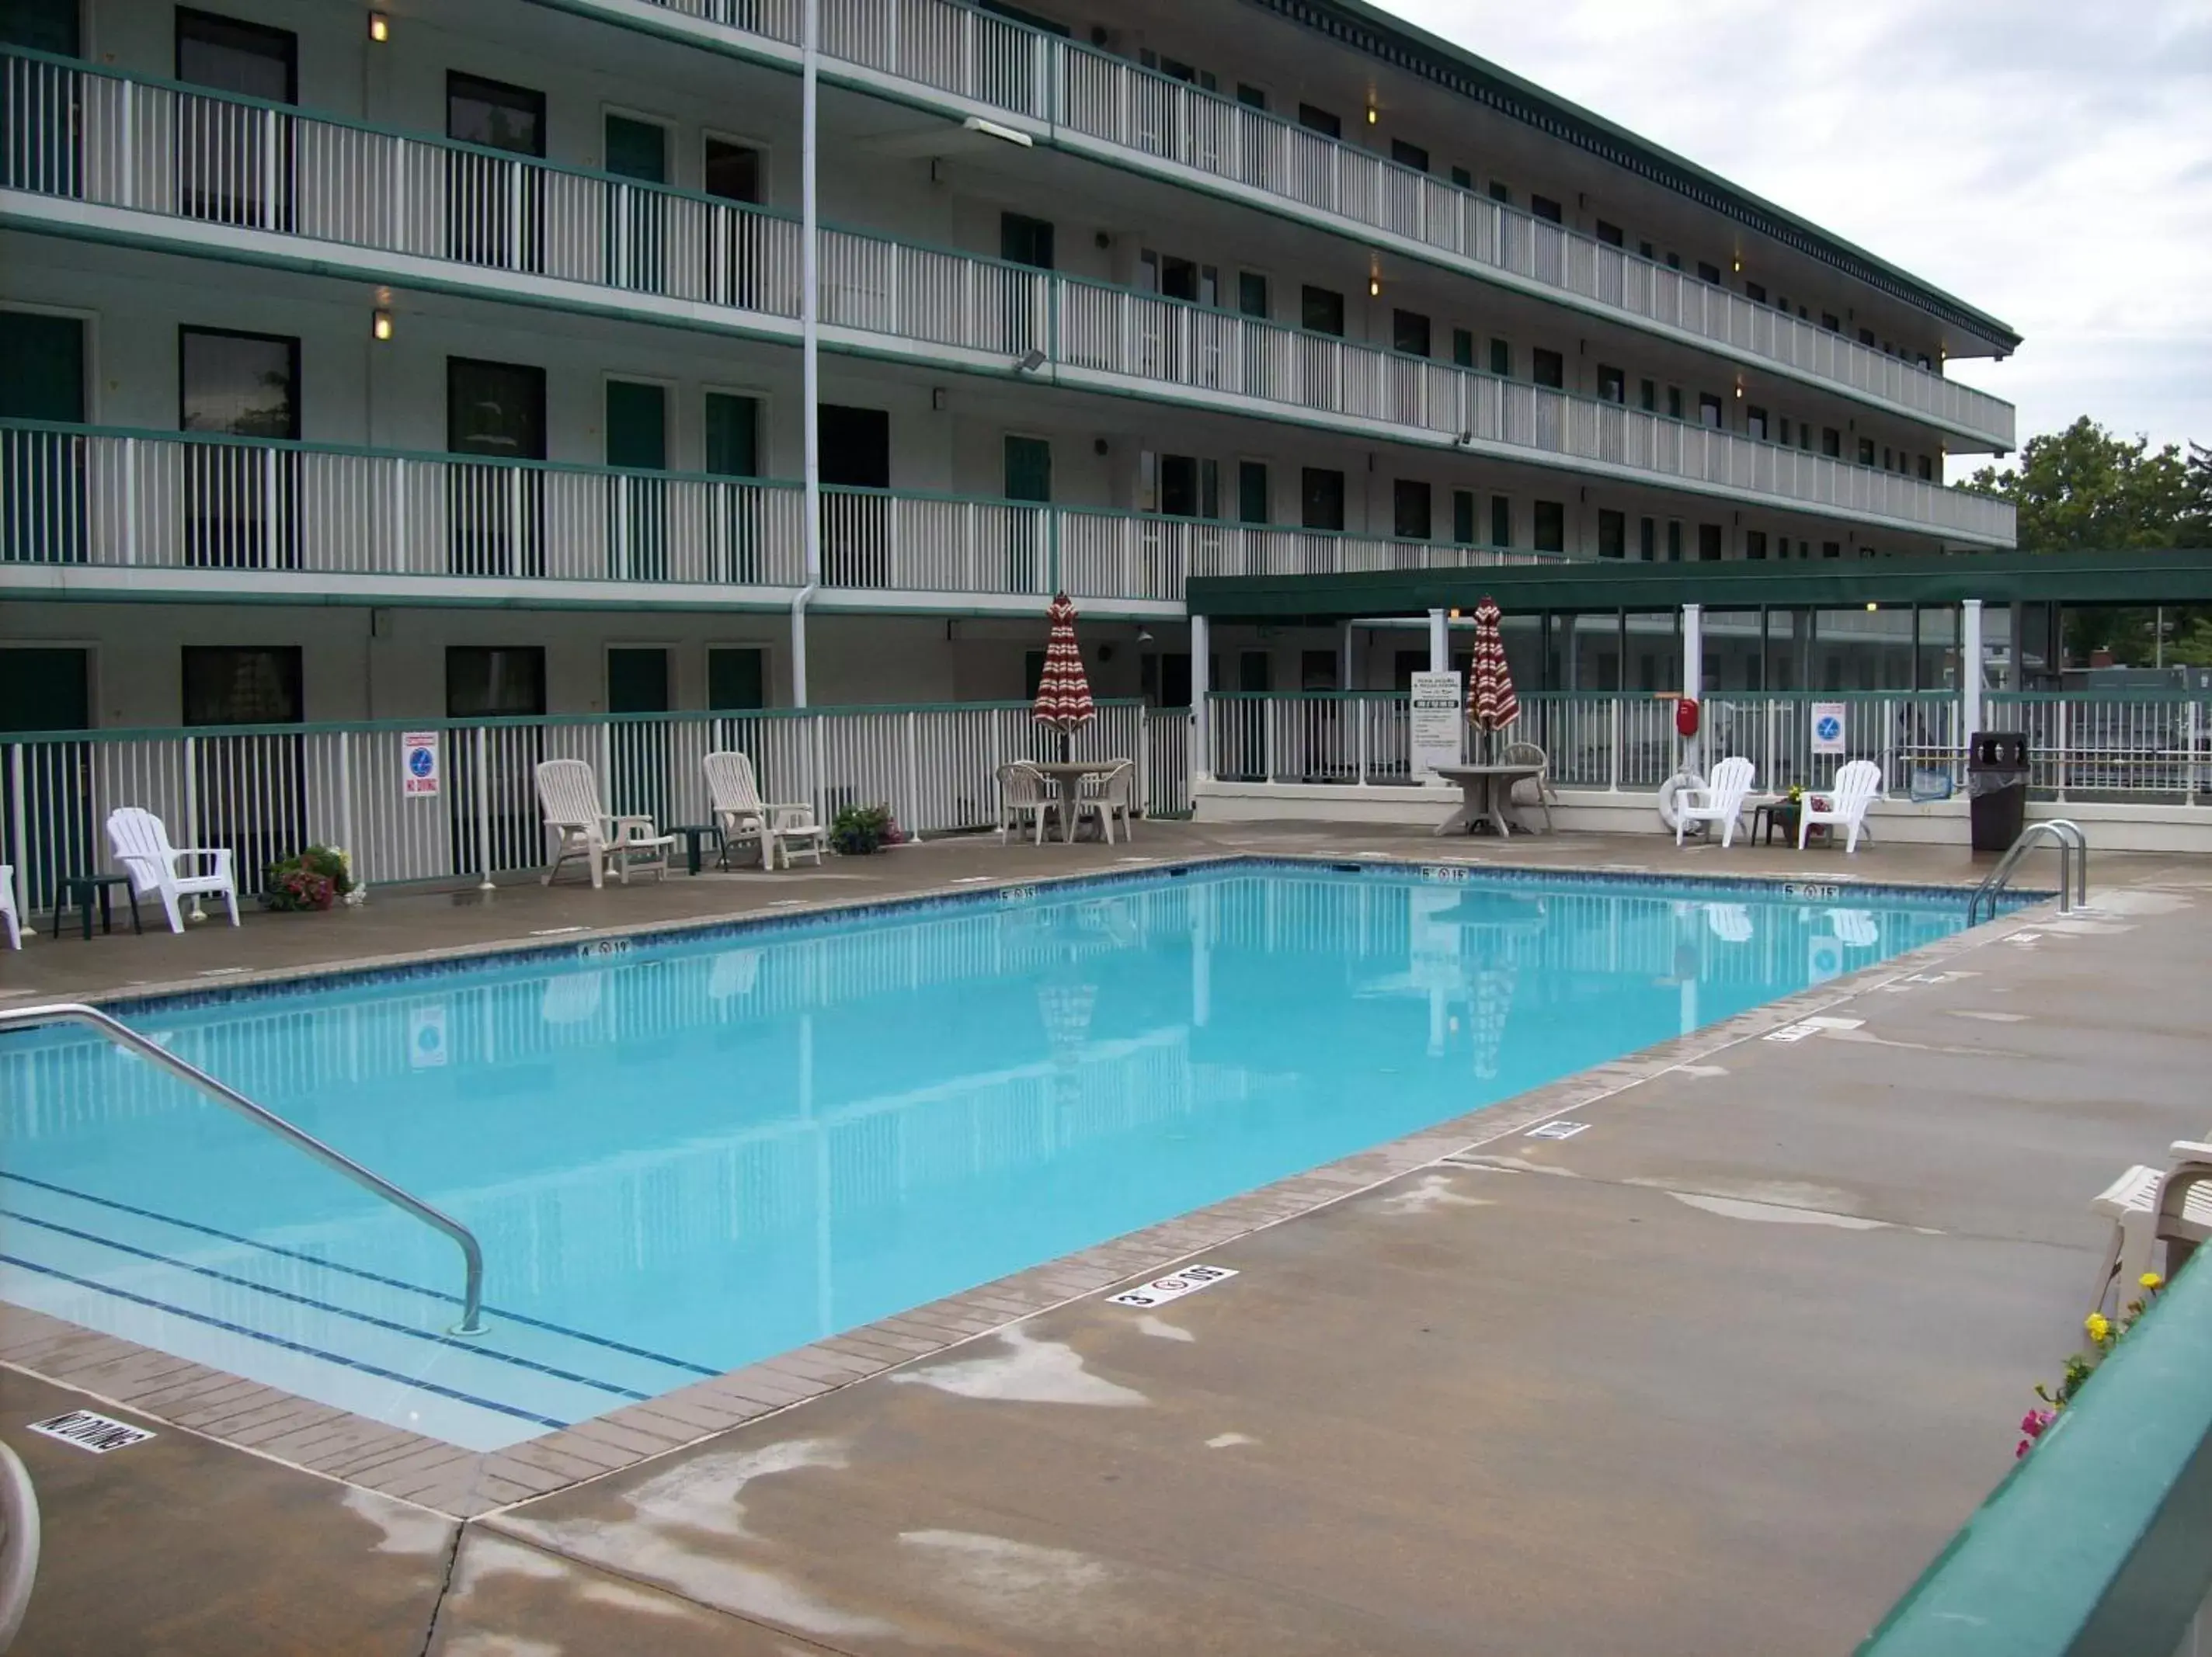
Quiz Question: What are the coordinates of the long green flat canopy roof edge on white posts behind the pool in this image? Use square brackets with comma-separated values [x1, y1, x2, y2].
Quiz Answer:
[1188, 549, 2212, 624]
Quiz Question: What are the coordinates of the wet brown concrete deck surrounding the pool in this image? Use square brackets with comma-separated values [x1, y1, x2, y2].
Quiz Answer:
[0, 825, 2212, 1657]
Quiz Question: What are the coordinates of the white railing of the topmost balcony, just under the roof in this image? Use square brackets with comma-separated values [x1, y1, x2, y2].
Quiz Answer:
[596, 0, 2013, 451]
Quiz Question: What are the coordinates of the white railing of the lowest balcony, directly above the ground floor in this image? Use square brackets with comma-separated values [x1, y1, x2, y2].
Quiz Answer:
[0, 420, 1542, 604]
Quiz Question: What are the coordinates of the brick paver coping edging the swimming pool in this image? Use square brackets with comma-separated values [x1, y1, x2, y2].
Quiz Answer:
[0, 854, 2055, 1520]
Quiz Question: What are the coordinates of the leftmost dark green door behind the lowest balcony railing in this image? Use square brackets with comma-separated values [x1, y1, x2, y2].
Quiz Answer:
[0, 310, 86, 561]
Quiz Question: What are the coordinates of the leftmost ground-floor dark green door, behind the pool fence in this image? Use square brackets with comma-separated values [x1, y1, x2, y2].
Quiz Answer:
[0, 646, 90, 909]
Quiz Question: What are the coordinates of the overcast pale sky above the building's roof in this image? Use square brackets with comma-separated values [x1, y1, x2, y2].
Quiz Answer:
[1382, 0, 2212, 471]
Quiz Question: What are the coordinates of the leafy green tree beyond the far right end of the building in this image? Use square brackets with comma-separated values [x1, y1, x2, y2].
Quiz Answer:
[1964, 414, 2212, 666]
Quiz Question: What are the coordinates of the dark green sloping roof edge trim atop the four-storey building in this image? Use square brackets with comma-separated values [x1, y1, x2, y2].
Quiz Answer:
[1252, 0, 2019, 352]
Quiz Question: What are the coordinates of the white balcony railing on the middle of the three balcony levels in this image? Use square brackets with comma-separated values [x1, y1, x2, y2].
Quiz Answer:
[0, 48, 2013, 547]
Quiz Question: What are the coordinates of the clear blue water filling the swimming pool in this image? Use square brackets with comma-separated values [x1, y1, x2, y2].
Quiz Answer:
[0, 865, 1964, 1449]
